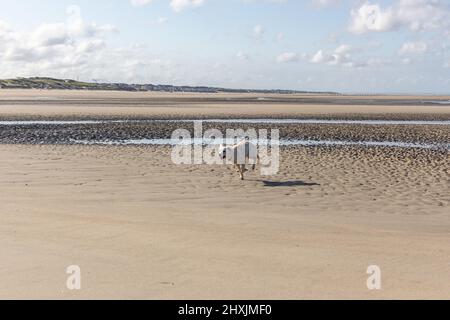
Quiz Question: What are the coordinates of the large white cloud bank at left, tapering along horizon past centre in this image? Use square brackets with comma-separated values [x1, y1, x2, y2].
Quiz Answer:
[0, 7, 239, 85]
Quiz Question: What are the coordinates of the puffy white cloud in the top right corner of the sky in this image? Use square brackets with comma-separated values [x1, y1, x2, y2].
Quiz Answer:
[349, 0, 450, 34]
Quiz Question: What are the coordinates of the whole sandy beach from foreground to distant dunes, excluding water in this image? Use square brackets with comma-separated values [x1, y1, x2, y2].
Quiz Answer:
[0, 90, 450, 299]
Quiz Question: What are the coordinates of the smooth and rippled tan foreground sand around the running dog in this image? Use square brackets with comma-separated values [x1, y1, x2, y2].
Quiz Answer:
[0, 145, 450, 299]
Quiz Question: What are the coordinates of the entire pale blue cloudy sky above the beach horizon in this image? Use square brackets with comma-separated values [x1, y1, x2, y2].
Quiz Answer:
[0, 0, 450, 94]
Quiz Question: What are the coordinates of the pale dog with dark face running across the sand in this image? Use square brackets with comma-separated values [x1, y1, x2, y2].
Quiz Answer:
[219, 140, 259, 180]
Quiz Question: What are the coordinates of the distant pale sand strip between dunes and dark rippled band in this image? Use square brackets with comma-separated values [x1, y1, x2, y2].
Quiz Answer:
[0, 90, 450, 120]
